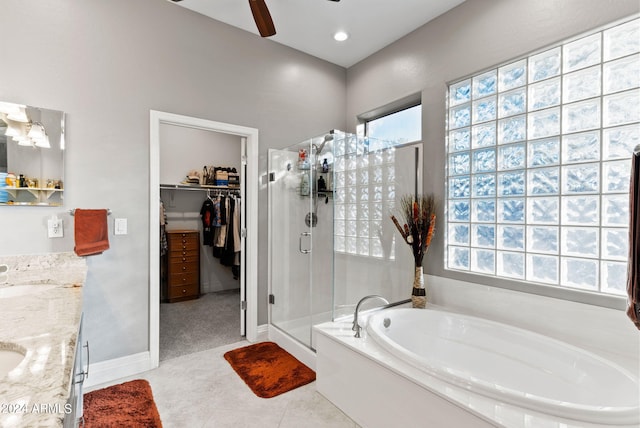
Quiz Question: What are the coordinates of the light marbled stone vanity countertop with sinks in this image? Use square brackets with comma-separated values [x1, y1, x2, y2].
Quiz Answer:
[0, 253, 87, 428]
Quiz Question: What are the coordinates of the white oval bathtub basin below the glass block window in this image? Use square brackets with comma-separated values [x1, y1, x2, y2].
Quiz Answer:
[364, 309, 640, 425]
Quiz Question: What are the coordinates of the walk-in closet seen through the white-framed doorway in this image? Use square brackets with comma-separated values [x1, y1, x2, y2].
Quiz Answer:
[159, 124, 245, 361]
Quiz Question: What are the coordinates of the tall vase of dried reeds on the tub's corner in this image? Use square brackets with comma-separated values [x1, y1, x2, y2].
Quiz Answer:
[391, 195, 436, 308]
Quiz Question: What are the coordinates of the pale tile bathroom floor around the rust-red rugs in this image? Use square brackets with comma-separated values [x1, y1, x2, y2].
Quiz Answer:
[87, 341, 358, 428]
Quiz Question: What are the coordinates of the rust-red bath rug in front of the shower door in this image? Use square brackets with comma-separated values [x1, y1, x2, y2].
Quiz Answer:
[224, 342, 316, 398]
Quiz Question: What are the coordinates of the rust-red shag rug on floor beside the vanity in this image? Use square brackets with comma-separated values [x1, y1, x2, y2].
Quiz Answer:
[84, 379, 162, 428]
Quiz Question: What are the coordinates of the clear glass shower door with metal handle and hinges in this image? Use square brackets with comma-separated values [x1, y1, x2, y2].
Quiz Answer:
[269, 140, 317, 347]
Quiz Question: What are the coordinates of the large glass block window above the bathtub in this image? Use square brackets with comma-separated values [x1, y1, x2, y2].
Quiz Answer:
[445, 19, 640, 295]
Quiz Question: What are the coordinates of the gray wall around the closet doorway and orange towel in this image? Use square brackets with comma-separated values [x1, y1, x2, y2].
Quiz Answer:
[0, 0, 346, 362]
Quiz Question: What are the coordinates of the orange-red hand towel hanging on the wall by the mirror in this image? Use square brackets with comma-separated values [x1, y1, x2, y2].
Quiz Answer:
[73, 209, 109, 256]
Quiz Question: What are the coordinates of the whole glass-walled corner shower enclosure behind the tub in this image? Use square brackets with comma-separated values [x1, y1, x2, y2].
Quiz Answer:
[269, 130, 422, 349]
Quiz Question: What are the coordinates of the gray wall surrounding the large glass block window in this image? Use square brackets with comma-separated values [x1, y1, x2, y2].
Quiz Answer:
[347, 0, 640, 285]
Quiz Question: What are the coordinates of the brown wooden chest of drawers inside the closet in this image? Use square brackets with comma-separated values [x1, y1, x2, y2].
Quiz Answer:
[166, 230, 200, 303]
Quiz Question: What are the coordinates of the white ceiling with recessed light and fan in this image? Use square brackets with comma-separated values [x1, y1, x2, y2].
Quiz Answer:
[166, 0, 464, 67]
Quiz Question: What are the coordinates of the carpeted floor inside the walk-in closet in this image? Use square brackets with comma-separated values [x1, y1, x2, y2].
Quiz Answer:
[160, 289, 242, 361]
